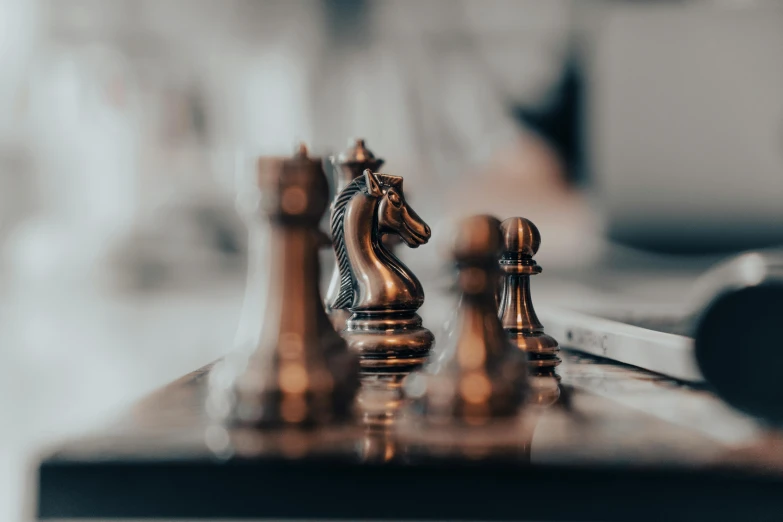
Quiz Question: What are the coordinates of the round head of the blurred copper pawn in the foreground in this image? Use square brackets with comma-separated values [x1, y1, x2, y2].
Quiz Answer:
[451, 214, 502, 263]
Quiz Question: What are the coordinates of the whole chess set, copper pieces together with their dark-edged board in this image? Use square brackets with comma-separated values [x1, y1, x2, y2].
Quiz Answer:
[38, 140, 783, 520]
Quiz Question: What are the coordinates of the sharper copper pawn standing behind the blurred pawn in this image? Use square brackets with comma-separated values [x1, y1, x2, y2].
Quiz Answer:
[499, 217, 560, 376]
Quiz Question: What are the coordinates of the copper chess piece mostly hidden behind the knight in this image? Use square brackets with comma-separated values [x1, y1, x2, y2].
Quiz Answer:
[324, 139, 384, 332]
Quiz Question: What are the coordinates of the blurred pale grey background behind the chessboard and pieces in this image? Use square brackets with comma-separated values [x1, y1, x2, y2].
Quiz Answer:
[0, 0, 783, 520]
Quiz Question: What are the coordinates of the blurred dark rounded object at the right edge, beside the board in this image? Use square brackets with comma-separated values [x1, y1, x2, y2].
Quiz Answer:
[693, 251, 783, 426]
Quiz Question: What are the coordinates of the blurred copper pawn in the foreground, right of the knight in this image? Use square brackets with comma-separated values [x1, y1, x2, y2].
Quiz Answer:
[406, 215, 528, 426]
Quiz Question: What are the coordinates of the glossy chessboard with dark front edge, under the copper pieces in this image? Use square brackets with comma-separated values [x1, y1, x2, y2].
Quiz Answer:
[38, 353, 783, 521]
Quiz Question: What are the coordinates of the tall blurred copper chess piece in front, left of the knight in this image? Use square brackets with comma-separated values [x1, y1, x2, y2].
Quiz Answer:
[231, 145, 359, 426]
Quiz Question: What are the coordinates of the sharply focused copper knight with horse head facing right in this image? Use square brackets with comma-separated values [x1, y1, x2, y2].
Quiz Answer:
[331, 169, 434, 371]
